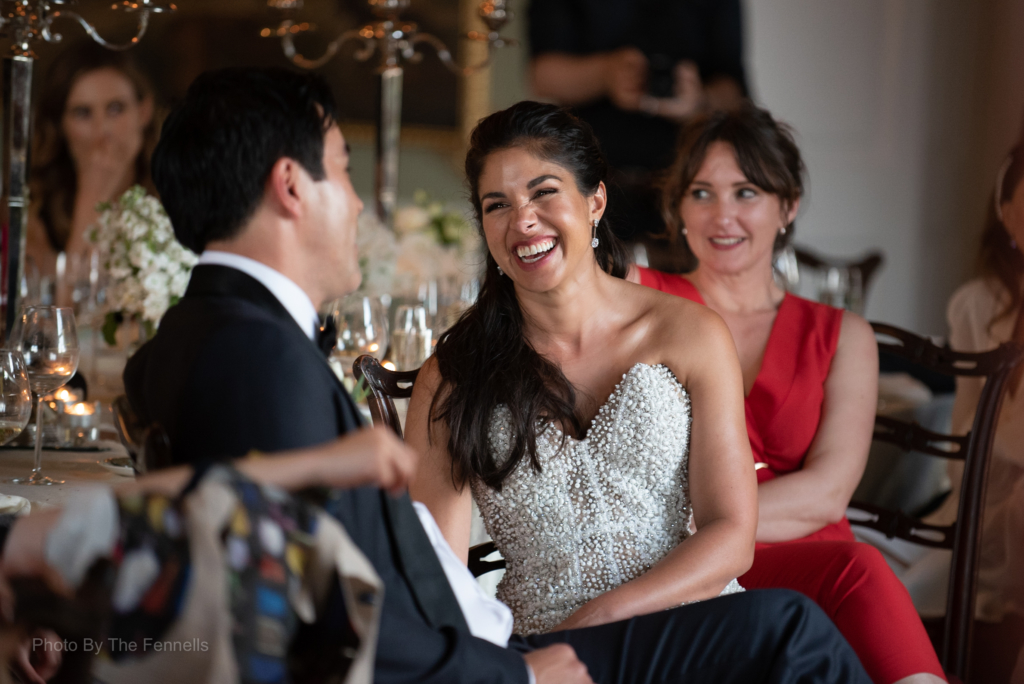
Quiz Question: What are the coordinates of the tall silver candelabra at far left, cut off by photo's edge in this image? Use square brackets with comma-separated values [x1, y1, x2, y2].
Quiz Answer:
[0, 0, 175, 338]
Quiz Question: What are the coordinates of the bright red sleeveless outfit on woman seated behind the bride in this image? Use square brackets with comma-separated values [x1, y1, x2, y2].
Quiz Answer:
[639, 267, 944, 684]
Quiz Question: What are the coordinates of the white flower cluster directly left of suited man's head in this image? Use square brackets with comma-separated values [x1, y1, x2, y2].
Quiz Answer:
[89, 185, 198, 345]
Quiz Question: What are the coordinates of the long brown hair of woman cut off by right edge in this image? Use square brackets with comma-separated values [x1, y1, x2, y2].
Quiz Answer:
[978, 143, 1024, 330]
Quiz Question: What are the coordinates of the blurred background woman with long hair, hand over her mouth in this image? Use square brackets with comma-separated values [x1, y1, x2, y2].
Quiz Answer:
[27, 42, 158, 305]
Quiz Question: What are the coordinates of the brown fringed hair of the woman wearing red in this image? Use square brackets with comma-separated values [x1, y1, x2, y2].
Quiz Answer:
[662, 104, 805, 266]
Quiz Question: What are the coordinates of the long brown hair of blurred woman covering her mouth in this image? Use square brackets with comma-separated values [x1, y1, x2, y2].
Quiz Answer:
[29, 42, 159, 252]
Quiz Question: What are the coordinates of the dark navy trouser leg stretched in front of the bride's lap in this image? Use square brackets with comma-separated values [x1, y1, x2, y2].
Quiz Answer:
[509, 589, 870, 684]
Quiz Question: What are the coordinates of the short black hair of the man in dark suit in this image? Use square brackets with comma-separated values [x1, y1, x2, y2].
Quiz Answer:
[153, 68, 336, 254]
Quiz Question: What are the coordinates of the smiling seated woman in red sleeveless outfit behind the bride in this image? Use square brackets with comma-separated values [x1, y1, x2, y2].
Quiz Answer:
[630, 108, 944, 684]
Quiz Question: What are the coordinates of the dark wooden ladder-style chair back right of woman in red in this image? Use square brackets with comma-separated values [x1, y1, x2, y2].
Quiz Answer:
[850, 324, 1024, 679]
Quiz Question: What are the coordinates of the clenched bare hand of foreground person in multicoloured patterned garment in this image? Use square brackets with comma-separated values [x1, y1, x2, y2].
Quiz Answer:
[319, 427, 419, 494]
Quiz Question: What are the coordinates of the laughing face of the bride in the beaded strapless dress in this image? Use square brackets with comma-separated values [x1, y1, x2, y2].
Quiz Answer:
[478, 147, 606, 292]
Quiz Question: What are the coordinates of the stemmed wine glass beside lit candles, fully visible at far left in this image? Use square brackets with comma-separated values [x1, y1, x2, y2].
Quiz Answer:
[11, 306, 78, 484]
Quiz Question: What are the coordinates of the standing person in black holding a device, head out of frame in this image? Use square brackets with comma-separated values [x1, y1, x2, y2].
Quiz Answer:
[529, 0, 746, 270]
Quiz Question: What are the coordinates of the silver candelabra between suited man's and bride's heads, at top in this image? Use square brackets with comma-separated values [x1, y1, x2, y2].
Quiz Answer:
[262, 0, 515, 227]
